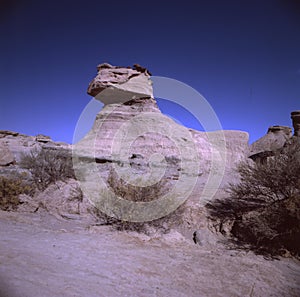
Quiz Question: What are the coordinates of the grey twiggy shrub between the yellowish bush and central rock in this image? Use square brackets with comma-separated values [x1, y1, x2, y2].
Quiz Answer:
[20, 149, 75, 190]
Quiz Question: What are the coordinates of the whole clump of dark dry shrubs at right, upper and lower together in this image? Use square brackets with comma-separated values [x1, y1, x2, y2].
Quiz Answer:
[207, 142, 300, 256]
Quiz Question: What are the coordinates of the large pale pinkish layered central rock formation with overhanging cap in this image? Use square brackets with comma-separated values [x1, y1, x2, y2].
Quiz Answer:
[74, 64, 248, 217]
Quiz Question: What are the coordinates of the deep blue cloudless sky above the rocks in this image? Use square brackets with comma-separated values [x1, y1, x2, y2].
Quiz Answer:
[0, 0, 300, 143]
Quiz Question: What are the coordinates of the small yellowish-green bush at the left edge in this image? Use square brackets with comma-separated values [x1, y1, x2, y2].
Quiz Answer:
[0, 176, 34, 210]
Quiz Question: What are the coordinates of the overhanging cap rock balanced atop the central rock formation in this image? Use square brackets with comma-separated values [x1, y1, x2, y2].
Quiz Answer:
[87, 63, 153, 104]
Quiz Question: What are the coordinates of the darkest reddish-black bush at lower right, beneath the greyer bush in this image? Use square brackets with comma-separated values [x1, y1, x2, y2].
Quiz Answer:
[231, 196, 300, 257]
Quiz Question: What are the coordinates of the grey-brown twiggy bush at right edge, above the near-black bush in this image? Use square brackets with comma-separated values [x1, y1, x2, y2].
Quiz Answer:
[229, 143, 300, 206]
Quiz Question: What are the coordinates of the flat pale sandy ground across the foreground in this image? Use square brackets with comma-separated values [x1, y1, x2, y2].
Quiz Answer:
[0, 212, 300, 297]
